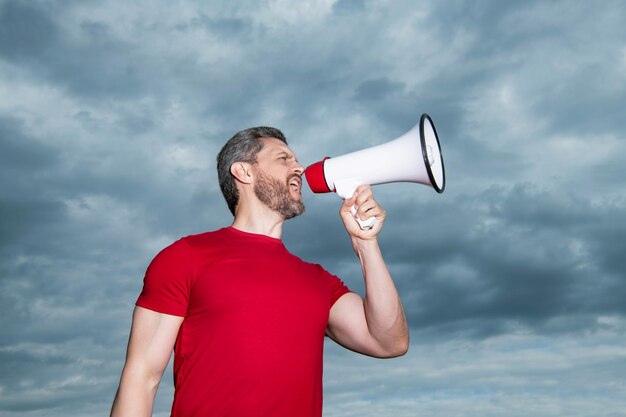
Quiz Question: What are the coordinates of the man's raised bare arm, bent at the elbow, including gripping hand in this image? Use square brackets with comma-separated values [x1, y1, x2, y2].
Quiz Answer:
[327, 186, 409, 358]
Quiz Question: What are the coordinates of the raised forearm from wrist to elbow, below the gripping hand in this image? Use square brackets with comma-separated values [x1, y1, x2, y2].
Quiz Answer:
[352, 238, 409, 356]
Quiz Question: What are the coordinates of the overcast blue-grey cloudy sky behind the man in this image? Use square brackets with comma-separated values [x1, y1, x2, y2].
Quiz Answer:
[0, 0, 626, 417]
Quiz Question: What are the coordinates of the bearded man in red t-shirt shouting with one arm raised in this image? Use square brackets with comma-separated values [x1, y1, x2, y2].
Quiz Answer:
[111, 127, 408, 417]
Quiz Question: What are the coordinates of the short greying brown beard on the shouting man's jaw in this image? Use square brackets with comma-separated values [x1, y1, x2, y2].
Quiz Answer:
[254, 172, 304, 220]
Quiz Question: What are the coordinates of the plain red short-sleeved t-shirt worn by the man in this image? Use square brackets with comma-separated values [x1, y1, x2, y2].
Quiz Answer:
[137, 227, 349, 417]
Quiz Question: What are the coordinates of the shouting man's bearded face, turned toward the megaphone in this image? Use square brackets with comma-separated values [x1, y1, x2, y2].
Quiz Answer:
[254, 138, 304, 220]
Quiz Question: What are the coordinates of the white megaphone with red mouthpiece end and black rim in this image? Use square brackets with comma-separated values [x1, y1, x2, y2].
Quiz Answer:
[304, 113, 446, 229]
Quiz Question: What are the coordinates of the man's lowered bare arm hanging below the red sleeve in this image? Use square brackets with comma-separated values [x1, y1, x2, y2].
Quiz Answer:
[111, 307, 183, 417]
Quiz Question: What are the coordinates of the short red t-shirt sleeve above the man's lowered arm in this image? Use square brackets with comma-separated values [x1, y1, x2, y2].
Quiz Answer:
[135, 239, 192, 317]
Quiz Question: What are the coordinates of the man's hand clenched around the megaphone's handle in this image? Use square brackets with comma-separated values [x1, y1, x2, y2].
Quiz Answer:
[339, 185, 387, 240]
